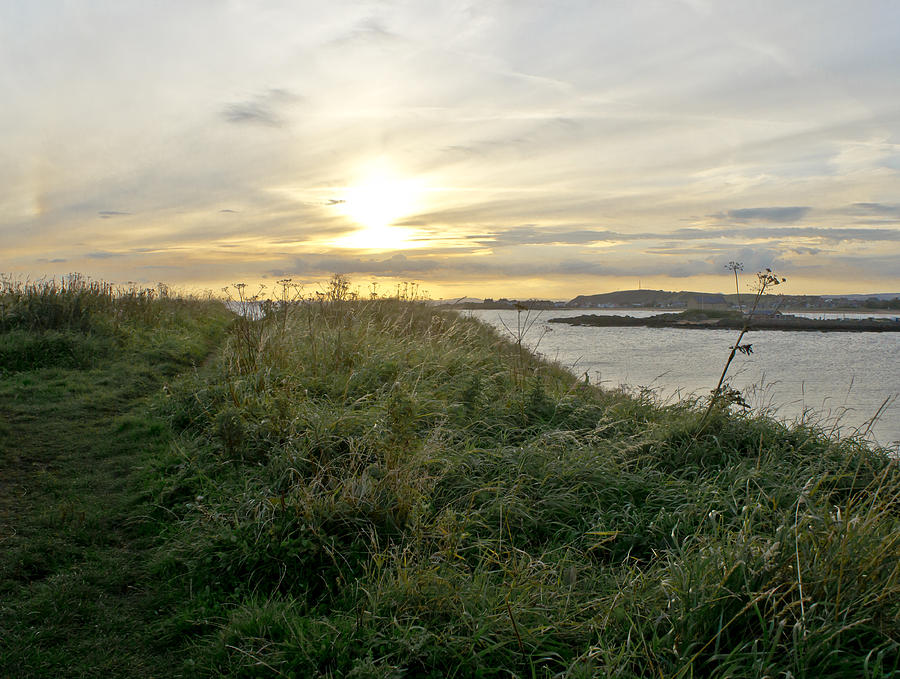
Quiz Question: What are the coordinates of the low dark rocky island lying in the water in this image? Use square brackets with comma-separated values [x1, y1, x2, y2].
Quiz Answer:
[548, 309, 900, 332]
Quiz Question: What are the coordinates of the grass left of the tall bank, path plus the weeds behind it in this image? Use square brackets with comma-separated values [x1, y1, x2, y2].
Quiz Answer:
[0, 276, 228, 677]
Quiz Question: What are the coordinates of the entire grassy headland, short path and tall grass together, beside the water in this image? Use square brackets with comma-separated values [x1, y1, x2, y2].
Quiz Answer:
[0, 280, 900, 678]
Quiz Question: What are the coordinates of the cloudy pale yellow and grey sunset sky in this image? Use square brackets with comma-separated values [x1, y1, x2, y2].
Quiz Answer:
[0, 0, 900, 299]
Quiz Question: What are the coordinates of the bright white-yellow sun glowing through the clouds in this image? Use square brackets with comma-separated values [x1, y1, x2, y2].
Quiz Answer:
[332, 165, 424, 250]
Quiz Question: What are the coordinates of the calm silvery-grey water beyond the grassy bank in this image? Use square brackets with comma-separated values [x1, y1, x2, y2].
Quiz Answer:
[469, 310, 900, 450]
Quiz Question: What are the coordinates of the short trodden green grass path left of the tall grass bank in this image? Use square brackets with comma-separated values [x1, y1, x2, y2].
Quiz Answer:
[0, 361, 219, 677]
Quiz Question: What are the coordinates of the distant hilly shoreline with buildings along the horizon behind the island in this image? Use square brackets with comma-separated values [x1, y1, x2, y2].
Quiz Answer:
[440, 290, 900, 312]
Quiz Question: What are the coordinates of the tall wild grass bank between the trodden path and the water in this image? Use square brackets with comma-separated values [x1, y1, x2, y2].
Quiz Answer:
[153, 286, 900, 677]
